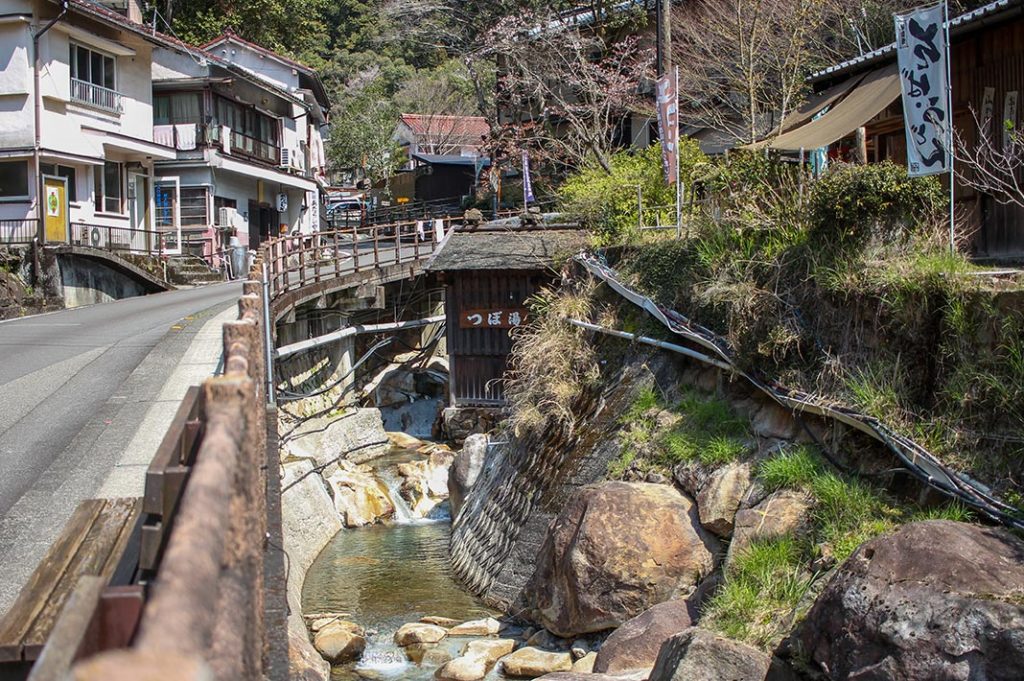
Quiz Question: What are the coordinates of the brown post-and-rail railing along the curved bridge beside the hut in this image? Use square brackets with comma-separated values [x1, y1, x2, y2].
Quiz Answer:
[262, 216, 461, 300]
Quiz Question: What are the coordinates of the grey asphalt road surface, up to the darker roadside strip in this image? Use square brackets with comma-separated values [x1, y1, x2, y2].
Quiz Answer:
[0, 284, 241, 522]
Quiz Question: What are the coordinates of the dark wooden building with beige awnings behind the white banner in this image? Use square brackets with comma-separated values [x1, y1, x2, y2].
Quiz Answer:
[768, 0, 1024, 260]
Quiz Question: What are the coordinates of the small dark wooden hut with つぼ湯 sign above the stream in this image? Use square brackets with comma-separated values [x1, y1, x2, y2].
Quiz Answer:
[427, 220, 586, 407]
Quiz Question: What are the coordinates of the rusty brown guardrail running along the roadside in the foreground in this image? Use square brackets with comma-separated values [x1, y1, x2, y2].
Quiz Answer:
[41, 281, 288, 681]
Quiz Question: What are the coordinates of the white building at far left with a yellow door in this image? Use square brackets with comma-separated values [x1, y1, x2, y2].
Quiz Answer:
[0, 0, 180, 249]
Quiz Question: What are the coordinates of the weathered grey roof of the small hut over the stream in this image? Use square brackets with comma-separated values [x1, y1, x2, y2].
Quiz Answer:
[426, 229, 587, 271]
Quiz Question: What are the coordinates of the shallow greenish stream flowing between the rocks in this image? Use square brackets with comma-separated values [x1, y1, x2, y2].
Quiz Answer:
[302, 450, 497, 681]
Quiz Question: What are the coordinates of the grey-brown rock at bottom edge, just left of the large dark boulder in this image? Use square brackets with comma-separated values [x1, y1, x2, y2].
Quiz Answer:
[649, 627, 771, 681]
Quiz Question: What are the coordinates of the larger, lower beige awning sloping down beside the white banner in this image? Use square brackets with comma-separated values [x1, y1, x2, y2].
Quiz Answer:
[768, 63, 900, 152]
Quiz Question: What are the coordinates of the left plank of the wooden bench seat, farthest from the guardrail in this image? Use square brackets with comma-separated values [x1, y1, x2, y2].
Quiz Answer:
[0, 499, 103, 662]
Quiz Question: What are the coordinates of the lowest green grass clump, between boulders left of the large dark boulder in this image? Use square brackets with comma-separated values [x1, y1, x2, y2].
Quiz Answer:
[701, 535, 811, 648]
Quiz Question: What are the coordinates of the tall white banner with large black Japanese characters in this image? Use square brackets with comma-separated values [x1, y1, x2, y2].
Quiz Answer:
[894, 4, 952, 177]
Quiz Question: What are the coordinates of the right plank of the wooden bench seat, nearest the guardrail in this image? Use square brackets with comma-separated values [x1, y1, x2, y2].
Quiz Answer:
[23, 499, 141, 659]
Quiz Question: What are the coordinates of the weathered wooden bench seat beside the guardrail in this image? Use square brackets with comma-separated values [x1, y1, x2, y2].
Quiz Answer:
[0, 498, 142, 667]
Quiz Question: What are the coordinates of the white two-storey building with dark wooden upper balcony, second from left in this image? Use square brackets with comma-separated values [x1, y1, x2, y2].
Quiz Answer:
[153, 27, 328, 253]
